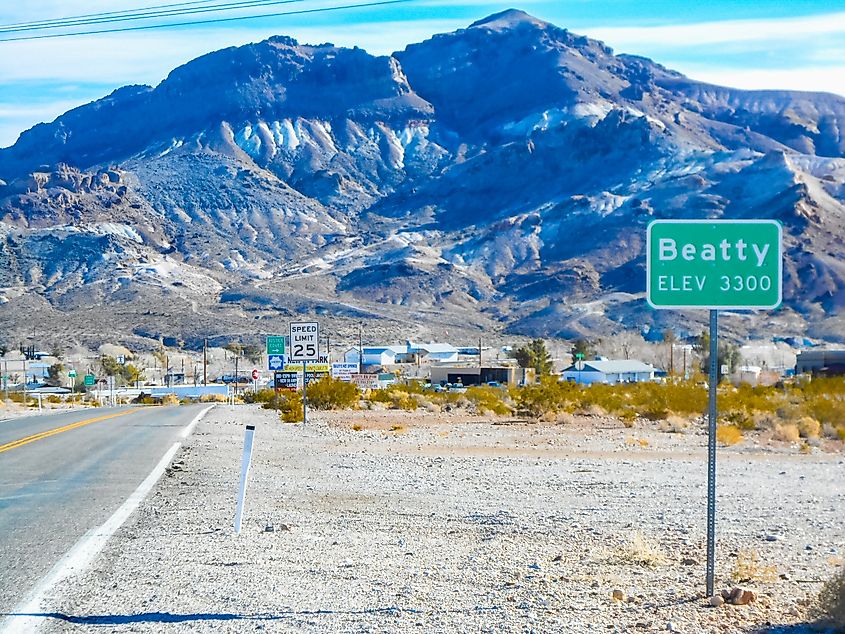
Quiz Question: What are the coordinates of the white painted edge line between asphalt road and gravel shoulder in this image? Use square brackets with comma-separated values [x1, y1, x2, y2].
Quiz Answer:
[0, 405, 214, 634]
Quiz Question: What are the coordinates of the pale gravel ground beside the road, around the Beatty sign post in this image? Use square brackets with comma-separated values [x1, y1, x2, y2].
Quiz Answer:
[39, 406, 845, 633]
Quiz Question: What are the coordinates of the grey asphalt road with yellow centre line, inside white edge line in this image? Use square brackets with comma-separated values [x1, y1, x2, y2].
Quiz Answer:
[0, 405, 205, 620]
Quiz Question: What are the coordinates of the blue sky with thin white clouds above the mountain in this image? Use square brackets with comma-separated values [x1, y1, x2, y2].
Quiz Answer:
[0, 0, 845, 147]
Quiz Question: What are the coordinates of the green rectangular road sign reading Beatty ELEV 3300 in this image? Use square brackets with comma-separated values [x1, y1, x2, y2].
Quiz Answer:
[646, 220, 783, 310]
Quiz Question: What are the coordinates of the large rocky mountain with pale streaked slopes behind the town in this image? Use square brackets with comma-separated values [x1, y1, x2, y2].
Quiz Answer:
[0, 10, 845, 345]
